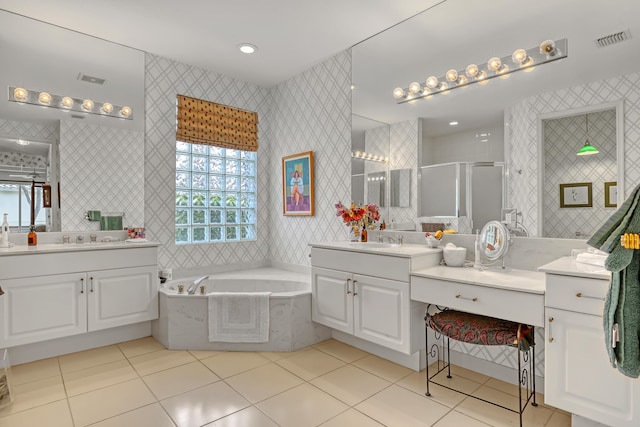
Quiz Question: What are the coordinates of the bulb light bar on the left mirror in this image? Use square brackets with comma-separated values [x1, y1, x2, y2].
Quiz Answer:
[9, 86, 133, 120]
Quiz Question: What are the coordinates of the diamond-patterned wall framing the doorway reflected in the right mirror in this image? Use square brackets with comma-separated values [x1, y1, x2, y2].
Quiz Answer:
[505, 73, 640, 234]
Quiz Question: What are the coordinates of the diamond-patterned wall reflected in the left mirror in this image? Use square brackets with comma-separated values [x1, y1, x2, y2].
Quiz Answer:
[60, 119, 145, 231]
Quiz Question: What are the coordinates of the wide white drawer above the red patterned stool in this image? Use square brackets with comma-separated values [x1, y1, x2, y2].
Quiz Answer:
[411, 276, 544, 326]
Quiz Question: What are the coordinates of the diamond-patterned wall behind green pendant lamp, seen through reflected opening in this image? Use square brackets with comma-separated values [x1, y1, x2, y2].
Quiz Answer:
[542, 110, 618, 239]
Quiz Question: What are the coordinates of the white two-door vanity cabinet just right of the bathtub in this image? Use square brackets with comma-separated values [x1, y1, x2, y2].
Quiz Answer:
[311, 245, 441, 354]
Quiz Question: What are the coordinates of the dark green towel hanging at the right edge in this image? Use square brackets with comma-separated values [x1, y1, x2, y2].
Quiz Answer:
[587, 186, 640, 378]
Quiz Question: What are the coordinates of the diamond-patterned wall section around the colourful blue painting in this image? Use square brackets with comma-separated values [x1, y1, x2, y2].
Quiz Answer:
[262, 51, 351, 266]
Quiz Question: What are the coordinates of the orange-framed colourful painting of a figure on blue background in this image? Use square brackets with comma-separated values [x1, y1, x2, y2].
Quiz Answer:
[282, 151, 314, 216]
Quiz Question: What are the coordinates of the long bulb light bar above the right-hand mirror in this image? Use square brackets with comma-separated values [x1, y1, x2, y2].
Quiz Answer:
[393, 38, 568, 104]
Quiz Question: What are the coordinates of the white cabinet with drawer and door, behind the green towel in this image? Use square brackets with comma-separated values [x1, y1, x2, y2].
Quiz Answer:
[540, 257, 640, 427]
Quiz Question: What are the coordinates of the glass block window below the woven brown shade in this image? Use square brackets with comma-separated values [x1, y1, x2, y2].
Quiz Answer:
[175, 141, 257, 244]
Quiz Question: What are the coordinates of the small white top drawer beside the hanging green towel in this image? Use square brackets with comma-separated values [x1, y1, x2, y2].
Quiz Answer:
[545, 273, 609, 316]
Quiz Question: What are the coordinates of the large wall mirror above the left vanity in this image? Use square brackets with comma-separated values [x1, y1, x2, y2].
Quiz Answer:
[0, 10, 145, 231]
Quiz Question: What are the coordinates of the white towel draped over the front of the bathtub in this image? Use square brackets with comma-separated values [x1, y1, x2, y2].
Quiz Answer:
[209, 292, 271, 343]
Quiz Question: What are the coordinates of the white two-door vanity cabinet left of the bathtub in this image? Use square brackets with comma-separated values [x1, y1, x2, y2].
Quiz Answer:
[0, 247, 158, 347]
